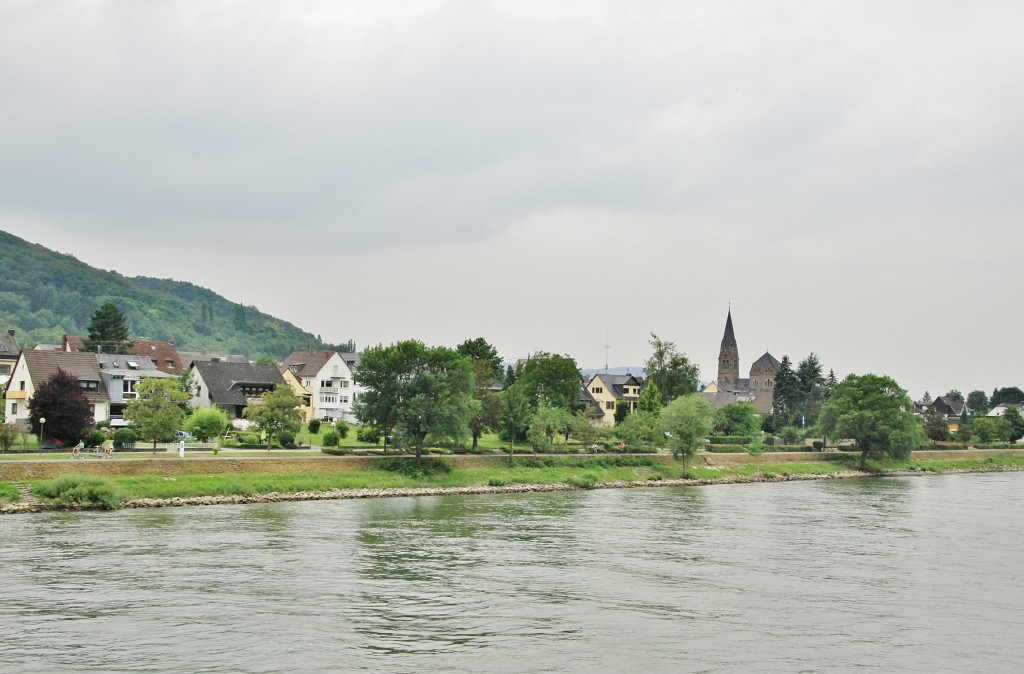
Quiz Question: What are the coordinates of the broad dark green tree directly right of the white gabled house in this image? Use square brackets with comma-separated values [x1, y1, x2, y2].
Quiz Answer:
[355, 340, 479, 462]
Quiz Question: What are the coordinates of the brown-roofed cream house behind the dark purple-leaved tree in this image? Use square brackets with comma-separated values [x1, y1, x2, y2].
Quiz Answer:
[4, 349, 111, 425]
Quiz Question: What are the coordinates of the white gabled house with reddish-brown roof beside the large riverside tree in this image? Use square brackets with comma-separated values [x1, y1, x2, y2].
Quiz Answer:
[281, 350, 355, 422]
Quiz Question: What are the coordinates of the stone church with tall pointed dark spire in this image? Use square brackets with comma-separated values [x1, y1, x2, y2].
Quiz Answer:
[702, 309, 781, 414]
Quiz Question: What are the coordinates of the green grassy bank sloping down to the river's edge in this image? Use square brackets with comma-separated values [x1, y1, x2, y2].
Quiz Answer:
[0, 451, 1024, 508]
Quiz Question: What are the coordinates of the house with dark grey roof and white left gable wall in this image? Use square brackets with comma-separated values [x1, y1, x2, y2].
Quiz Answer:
[188, 361, 286, 419]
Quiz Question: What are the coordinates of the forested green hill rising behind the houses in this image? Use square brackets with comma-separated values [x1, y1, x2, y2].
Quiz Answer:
[0, 231, 348, 359]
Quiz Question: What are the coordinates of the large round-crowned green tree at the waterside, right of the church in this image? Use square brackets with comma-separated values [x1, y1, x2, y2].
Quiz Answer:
[818, 374, 926, 470]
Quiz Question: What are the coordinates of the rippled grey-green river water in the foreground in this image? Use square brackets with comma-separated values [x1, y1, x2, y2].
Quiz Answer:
[0, 473, 1024, 673]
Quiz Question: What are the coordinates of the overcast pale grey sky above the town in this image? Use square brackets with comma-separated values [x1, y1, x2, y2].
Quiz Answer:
[0, 0, 1024, 397]
